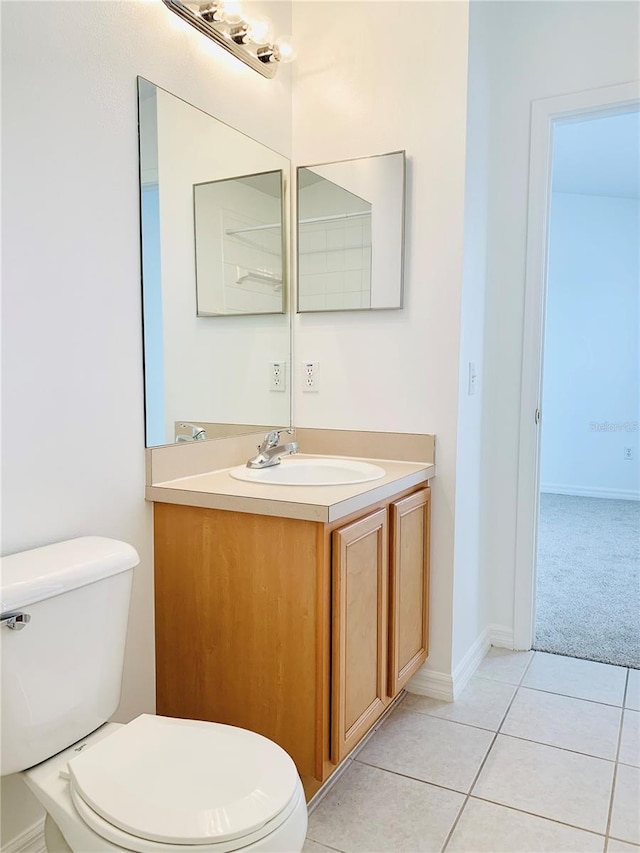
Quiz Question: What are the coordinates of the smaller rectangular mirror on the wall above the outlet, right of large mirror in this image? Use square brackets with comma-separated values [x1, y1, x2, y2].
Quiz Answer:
[297, 151, 405, 313]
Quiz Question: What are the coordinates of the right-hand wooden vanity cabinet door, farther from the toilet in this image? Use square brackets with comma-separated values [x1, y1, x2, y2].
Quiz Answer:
[388, 488, 431, 697]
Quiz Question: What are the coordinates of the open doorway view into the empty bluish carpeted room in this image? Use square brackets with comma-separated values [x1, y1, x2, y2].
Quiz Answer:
[533, 110, 640, 667]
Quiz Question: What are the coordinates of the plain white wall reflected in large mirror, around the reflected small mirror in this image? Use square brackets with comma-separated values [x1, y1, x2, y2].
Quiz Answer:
[151, 89, 290, 442]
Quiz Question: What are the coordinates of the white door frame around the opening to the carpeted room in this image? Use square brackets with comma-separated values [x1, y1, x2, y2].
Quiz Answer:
[513, 81, 640, 649]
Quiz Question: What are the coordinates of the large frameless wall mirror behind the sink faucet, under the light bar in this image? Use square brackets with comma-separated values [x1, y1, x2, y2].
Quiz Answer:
[138, 78, 291, 447]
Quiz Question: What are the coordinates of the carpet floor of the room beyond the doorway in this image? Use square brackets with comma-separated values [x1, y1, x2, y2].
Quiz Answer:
[534, 494, 640, 669]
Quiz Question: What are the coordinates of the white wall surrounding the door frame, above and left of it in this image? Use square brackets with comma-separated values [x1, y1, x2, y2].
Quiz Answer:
[469, 2, 640, 631]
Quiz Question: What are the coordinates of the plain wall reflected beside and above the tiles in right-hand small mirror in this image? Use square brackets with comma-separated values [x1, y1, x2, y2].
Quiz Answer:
[302, 152, 404, 308]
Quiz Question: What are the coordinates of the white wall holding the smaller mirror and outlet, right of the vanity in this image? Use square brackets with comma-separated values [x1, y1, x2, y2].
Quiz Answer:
[293, 2, 468, 673]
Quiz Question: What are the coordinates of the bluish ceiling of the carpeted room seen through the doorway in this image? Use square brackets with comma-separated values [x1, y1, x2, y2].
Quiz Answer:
[553, 110, 640, 198]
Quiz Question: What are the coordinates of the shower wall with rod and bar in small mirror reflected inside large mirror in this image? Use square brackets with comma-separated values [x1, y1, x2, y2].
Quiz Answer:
[195, 179, 282, 316]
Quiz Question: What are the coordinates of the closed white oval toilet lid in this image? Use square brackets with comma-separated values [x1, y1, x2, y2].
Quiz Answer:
[69, 714, 298, 845]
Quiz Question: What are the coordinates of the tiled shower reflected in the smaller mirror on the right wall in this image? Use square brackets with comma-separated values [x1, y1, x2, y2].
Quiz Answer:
[298, 178, 371, 311]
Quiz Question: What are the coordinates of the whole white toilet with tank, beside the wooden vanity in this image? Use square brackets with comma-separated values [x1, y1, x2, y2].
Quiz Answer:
[0, 537, 307, 853]
